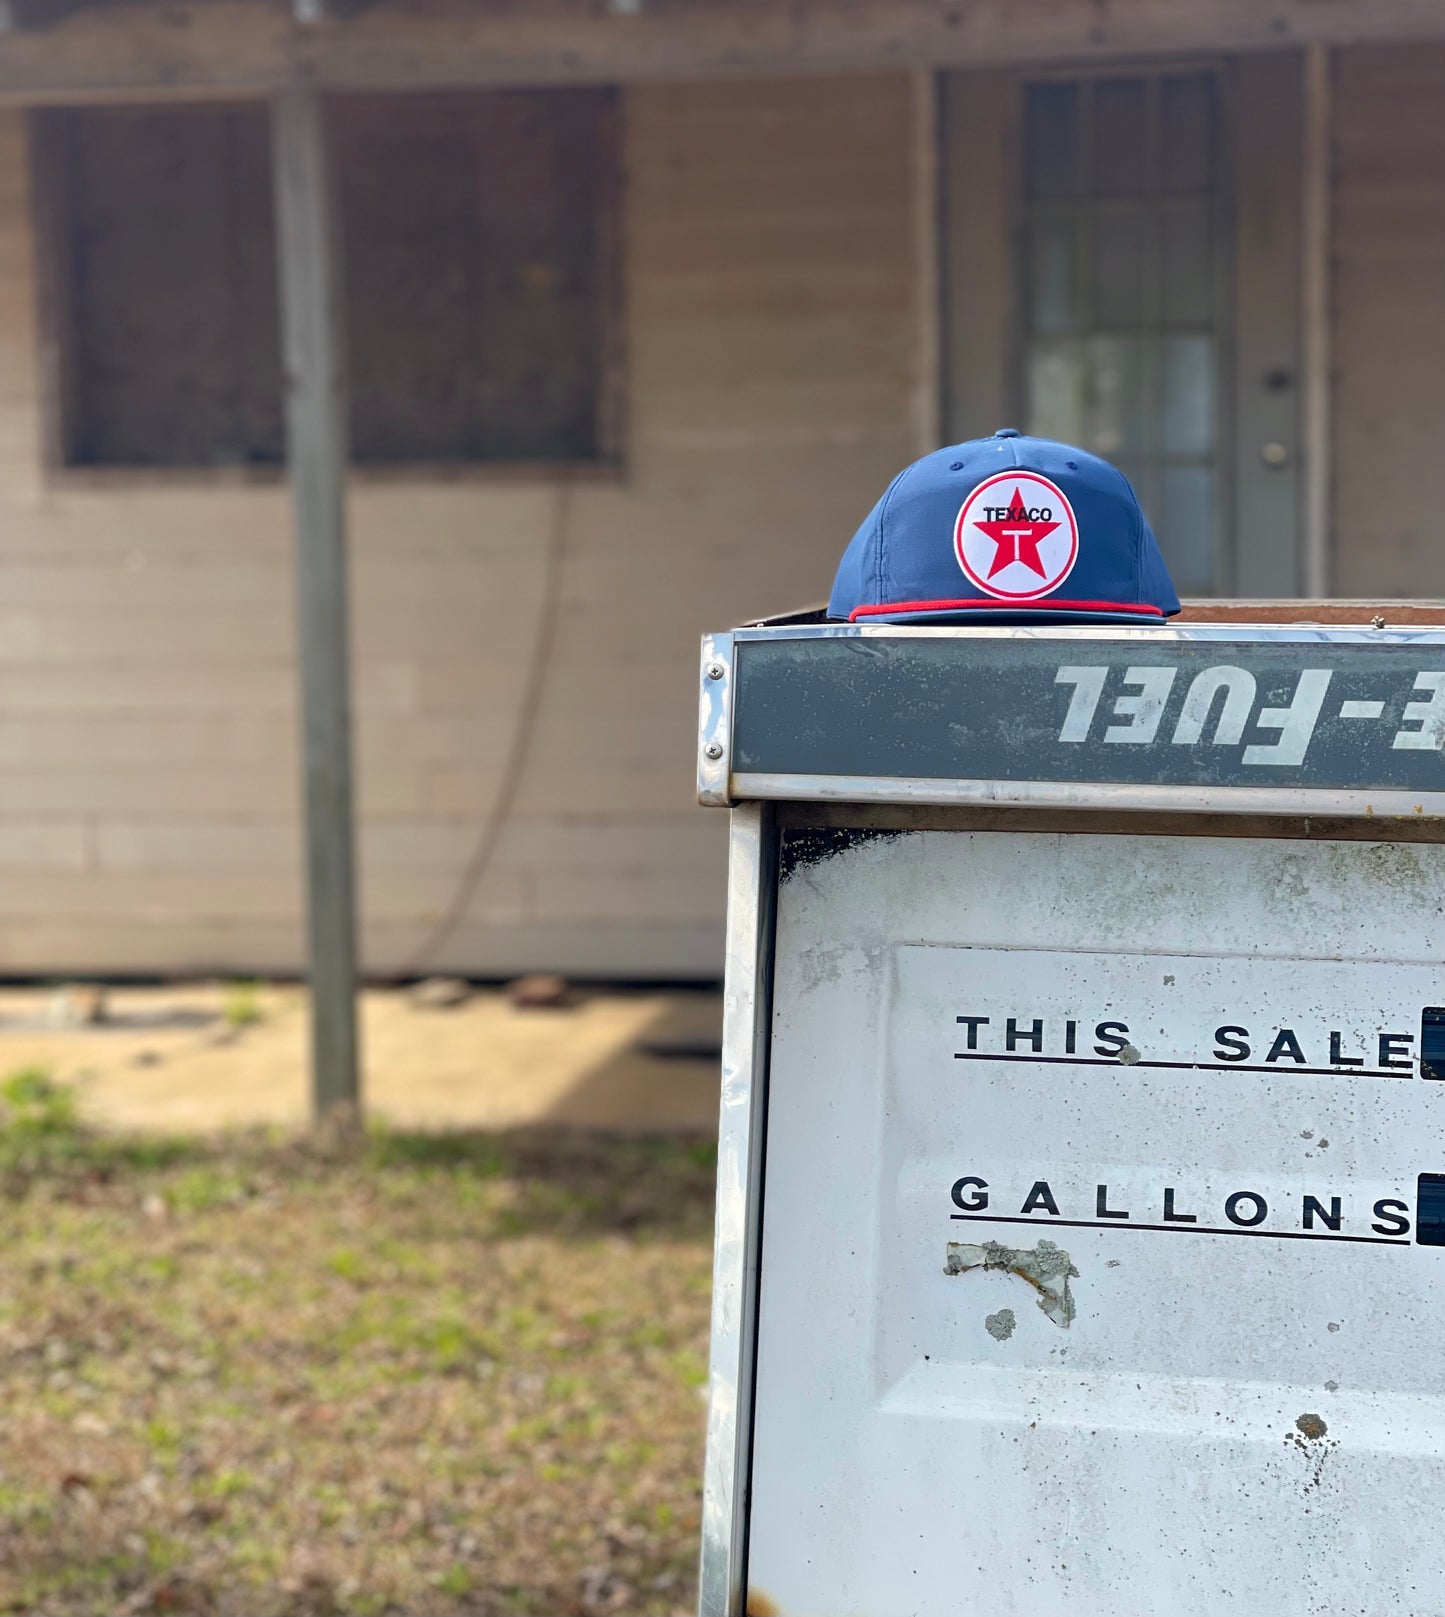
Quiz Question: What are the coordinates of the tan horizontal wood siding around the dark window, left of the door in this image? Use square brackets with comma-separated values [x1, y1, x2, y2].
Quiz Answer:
[0, 74, 915, 975]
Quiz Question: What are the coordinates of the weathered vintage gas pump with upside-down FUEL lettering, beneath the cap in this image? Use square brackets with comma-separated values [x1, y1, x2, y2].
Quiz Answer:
[700, 603, 1445, 1617]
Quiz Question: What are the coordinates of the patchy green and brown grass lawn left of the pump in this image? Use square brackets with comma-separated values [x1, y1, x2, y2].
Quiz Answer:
[0, 1074, 713, 1617]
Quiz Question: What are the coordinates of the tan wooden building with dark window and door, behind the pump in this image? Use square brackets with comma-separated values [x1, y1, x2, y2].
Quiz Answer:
[0, 0, 1445, 977]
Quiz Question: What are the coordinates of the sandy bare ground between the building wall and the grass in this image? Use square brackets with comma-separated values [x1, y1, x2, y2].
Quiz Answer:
[0, 983, 721, 1134]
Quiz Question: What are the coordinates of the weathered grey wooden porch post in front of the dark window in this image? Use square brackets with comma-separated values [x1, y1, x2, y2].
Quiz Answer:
[272, 84, 360, 1121]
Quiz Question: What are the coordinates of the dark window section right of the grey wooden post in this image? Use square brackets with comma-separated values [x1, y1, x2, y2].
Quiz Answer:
[335, 91, 611, 461]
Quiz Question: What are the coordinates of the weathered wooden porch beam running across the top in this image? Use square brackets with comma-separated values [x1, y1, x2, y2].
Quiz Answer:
[0, 0, 1445, 102]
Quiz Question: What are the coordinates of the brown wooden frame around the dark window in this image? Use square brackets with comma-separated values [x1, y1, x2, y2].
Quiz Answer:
[24, 86, 627, 490]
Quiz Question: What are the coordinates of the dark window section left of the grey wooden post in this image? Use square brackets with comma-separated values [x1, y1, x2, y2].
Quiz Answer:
[42, 107, 283, 466]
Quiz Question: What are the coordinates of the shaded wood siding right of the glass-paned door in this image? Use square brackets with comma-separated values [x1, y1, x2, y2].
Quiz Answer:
[1332, 45, 1445, 598]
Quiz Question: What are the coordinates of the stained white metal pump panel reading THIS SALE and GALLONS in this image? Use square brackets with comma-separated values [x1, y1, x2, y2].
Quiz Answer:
[748, 831, 1445, 1617]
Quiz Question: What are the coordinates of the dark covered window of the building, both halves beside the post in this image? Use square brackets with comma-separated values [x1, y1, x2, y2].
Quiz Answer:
[36, 91, 616, 466]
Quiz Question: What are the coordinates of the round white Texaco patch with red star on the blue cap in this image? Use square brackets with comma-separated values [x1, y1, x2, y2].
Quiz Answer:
[954, 472, 1078, 602]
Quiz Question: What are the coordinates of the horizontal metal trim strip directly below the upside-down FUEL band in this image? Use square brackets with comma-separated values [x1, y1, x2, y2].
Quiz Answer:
[729, 775, 1445, 820]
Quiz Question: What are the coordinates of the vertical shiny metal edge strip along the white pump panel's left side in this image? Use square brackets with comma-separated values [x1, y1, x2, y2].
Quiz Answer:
[698, 804, 777, 1617]
